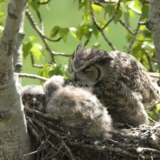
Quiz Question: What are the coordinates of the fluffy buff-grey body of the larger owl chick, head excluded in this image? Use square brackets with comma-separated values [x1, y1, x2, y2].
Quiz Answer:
[46, 86, 112, 138]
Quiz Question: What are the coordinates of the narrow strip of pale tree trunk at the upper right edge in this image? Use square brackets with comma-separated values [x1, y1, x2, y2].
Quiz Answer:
[147, 0, 160, 71]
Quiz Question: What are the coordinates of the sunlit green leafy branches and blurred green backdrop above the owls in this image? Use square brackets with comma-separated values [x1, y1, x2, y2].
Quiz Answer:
[0, 0, 159, 117]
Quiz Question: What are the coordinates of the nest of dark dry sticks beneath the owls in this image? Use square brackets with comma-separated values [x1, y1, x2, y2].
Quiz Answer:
[25, 108, 160, 160]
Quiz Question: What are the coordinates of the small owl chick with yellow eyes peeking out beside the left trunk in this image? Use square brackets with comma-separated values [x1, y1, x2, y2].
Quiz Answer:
[21, 85, 45, 112]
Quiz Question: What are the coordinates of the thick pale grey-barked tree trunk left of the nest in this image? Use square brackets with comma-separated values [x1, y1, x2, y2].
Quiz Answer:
[0, 0, 31, 160]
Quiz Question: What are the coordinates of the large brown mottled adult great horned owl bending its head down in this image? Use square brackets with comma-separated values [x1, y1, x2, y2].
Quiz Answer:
[71, 45, 159, 126]
